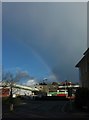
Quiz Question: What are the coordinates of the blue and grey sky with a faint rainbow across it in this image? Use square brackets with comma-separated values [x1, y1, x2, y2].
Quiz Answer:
[2, 2, 87, 84]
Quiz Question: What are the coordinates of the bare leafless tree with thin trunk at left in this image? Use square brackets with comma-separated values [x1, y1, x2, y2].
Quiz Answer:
[2, 70, 29, 111]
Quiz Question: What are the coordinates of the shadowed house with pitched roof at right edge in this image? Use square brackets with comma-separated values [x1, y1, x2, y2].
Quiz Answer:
[75, 48, 89, 89]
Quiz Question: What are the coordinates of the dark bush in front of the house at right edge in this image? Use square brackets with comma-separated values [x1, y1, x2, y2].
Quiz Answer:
[74, 87, 89, 109]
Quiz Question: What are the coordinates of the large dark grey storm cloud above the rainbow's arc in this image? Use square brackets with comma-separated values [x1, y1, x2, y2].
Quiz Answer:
[3, 3, 87, 80]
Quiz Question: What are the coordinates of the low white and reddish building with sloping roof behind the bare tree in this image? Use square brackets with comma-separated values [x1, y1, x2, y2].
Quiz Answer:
[0, 84, 39, 97]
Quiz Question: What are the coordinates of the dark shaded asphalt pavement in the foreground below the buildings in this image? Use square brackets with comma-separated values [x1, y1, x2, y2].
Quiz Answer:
[2, 100, 89, 120]
